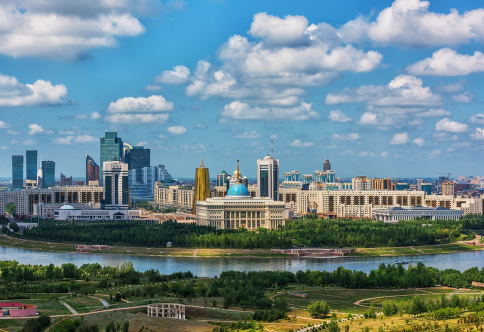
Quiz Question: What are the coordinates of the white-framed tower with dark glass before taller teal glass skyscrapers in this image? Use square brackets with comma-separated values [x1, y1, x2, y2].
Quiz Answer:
[103, 161, 129, 209]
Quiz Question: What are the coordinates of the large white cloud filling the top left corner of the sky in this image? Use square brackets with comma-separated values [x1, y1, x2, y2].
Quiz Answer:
[0, 0, 147, 60]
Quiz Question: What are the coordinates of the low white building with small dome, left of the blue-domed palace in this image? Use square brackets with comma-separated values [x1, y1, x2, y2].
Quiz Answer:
[54, 205, 141, 221]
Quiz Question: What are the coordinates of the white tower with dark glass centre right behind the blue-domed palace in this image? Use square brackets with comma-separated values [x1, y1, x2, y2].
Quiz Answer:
[257, 155, 279, 201]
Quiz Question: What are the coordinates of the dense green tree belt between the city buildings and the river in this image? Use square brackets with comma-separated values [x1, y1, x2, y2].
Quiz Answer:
[18, 215, 484, 249]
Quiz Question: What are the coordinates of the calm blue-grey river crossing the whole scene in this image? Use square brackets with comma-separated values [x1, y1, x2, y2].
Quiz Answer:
[0, 246, 484, 277]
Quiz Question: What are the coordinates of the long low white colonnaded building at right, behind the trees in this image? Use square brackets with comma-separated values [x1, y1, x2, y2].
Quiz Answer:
[373, 205, 464, 223]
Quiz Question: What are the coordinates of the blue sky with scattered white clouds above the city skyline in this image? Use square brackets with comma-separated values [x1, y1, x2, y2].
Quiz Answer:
[0, 0, 484, 177]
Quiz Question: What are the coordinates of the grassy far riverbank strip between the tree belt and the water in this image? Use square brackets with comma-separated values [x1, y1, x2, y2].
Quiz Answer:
[0, 235, 484, 258]
